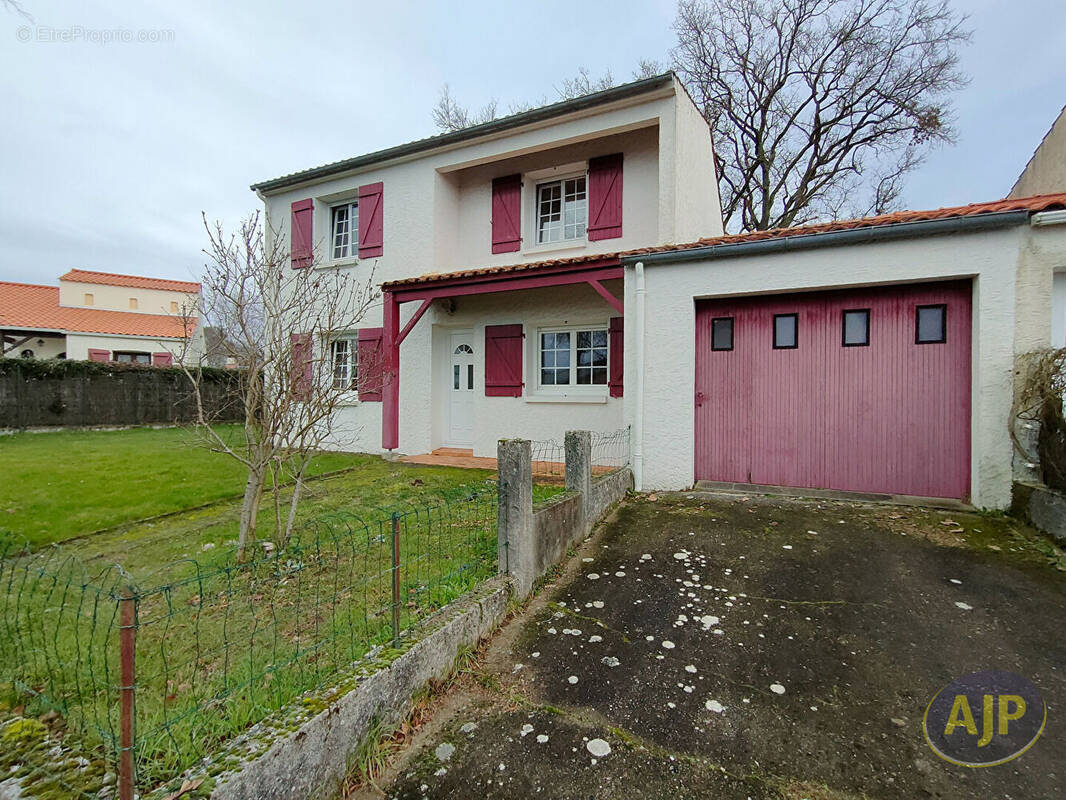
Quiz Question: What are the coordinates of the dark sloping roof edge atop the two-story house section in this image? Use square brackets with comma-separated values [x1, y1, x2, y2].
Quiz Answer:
[252, 71, 674, 192]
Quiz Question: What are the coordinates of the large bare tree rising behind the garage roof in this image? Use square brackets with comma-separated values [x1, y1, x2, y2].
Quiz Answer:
[674, 0, 970, 230]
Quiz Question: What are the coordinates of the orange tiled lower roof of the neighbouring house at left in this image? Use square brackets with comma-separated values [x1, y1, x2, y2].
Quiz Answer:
[0, 282, 196, 339]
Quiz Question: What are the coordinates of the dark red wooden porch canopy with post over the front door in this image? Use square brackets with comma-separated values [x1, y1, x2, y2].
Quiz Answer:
[382, 254, 623, 450]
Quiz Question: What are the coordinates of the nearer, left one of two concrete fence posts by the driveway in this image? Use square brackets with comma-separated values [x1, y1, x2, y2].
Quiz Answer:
[496, 438, 537, 595]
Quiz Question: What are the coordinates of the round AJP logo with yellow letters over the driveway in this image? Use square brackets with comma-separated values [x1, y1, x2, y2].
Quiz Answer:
[922, 670, 1048, 767]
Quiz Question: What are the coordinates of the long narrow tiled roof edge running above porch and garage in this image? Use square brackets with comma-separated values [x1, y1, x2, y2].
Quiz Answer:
[382, 193, 1066, 289]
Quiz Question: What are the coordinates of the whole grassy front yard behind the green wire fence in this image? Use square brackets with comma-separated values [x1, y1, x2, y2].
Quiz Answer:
[0, 429, 562, 796]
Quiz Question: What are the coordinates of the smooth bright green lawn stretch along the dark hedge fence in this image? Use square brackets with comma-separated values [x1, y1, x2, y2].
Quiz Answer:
[0, 426, 388, 547]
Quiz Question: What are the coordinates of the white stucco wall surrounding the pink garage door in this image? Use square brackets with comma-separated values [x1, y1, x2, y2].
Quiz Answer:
[625, 219, 1066, 508]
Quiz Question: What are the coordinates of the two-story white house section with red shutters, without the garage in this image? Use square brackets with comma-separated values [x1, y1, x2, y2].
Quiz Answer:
[253, 75, 722, 462]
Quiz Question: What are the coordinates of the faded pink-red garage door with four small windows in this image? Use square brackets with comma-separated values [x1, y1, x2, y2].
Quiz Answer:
[695, 282, 971, 498]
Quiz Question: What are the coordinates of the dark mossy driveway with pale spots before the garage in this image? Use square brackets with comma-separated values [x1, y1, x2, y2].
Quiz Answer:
[370, 495, 1066, 800]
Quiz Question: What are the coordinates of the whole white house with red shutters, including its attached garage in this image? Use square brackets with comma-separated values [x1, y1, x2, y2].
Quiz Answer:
[253, 68, 1066, 508]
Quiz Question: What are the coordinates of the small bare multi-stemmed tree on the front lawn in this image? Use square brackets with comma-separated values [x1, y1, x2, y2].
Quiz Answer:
[179, 212, 376, 561]
